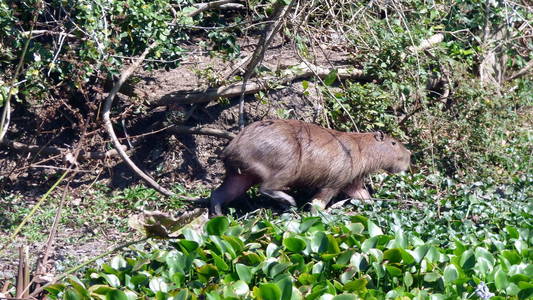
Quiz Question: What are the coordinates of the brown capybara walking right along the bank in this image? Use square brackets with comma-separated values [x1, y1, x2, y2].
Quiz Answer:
[209, 120, 411, 216]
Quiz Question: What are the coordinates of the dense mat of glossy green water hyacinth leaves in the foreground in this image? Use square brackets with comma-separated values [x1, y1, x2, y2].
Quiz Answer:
[43, 206, 533, 300]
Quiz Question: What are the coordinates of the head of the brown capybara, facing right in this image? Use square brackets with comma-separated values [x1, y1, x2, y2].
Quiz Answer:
[373, 131, 411, 173]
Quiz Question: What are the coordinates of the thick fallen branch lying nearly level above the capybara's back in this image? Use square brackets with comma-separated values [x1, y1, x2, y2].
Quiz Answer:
[156, 64, 366, 106]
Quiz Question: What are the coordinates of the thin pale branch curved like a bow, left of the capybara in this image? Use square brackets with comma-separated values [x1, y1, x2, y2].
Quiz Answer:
[102, 42, 174, 196]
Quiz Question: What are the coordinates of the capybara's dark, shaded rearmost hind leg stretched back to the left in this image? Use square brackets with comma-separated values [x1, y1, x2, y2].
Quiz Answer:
[209, 174, 255, 216]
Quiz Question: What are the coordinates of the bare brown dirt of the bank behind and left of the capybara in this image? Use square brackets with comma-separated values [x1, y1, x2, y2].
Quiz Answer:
[0, 37, 345, 280]
